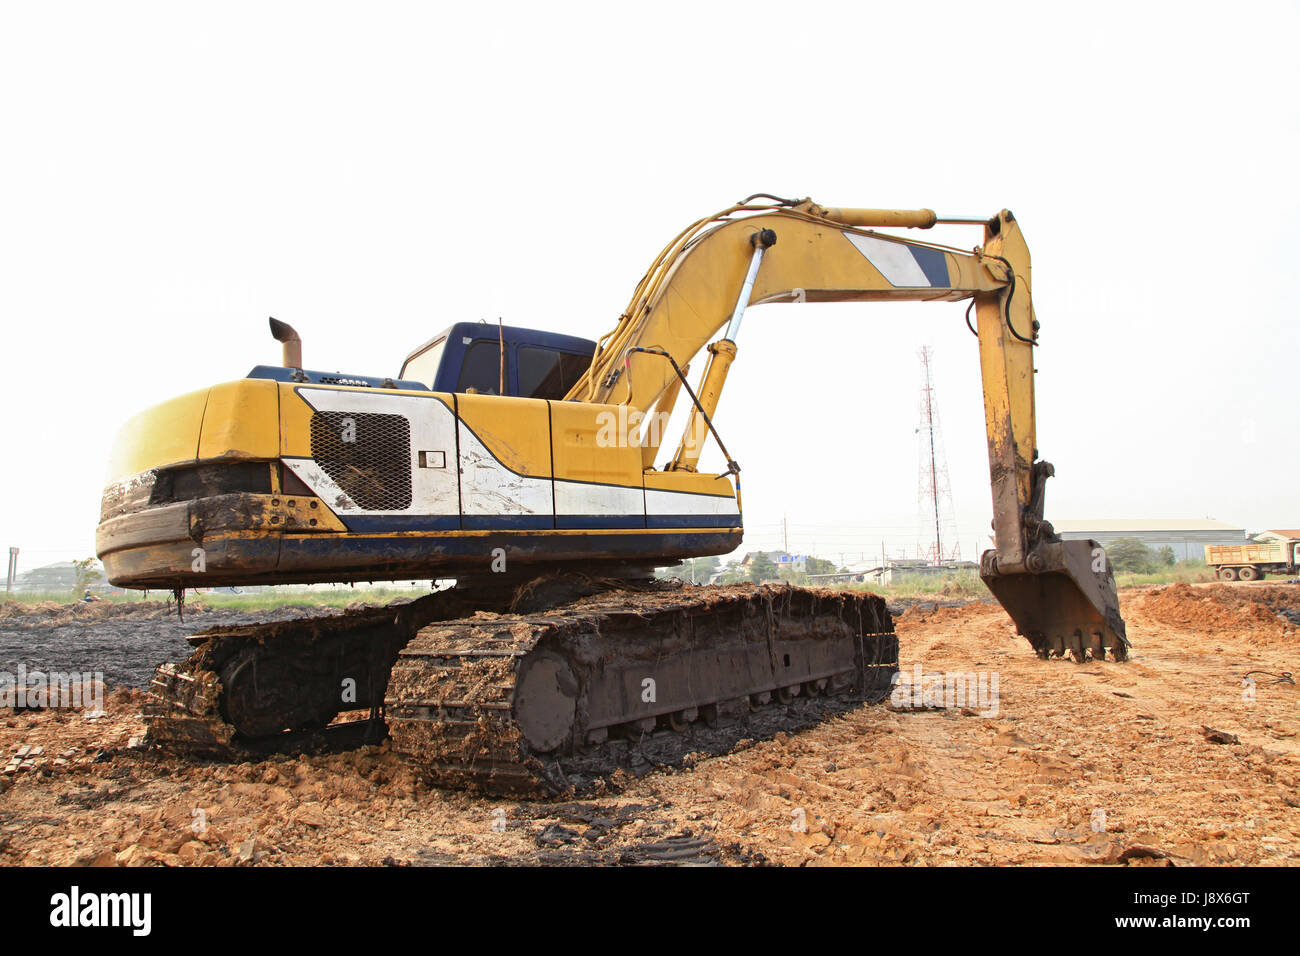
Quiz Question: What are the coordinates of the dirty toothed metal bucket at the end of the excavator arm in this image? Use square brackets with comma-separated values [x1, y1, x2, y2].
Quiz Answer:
[980, 541, 1130, 662]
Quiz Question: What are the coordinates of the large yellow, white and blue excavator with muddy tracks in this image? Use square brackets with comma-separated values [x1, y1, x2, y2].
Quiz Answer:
[98, 194, 1128, 792]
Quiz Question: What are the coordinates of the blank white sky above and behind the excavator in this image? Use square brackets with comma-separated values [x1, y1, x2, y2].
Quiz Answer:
[0, 0, 1300, 568]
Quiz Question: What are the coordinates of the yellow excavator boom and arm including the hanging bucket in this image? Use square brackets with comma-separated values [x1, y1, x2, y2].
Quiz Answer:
[567, 196, 1128, 659]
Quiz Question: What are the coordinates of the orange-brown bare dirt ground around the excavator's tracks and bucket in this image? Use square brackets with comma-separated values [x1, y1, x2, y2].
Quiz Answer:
[0, 584, 1300, 866]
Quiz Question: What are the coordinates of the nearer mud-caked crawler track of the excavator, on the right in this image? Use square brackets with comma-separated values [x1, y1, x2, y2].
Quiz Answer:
[385, 587, 898, 796]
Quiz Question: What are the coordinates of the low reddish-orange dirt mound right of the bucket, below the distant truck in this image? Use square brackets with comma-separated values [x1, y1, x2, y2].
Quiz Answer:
[1140, 583, 1296, 640]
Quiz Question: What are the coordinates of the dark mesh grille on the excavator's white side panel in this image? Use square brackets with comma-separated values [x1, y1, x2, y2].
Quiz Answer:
[312, 411, 411, 511]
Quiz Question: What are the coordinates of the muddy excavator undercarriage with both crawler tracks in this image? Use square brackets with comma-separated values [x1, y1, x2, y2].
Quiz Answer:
[144, 575, 898, 796]
